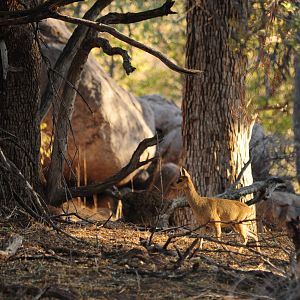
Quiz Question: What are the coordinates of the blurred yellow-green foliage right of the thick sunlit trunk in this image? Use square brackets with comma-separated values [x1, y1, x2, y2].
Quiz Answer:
[246, 0, 300, 136]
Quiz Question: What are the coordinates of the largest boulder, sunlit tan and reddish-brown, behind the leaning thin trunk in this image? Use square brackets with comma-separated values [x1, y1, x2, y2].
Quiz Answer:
[42, 20, 155, 181]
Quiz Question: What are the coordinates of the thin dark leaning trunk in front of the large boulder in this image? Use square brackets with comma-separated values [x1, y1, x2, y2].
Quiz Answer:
[45, 0, 112, 203]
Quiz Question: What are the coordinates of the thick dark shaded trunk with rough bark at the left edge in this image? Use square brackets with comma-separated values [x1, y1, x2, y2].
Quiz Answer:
[0, 0, 41, 208]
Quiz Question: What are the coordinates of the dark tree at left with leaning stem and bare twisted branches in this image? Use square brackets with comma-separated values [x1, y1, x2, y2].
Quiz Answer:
[0, 0, 197, 218]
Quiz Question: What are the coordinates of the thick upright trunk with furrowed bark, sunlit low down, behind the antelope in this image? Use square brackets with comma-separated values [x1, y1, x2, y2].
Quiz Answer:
[182, 0, 253, 195]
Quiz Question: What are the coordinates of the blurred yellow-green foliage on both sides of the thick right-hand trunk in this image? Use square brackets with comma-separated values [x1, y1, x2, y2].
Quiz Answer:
[64, 0, 300, 135]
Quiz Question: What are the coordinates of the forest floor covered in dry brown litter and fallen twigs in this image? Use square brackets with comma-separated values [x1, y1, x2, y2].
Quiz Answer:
[0, 221, 297, 299]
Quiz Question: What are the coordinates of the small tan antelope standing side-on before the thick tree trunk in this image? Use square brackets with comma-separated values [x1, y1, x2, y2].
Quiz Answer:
[175, 168, 260, 251]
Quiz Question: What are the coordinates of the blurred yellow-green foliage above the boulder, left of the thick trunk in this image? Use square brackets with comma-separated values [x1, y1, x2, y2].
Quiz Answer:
[96, 1, 186, 104]
